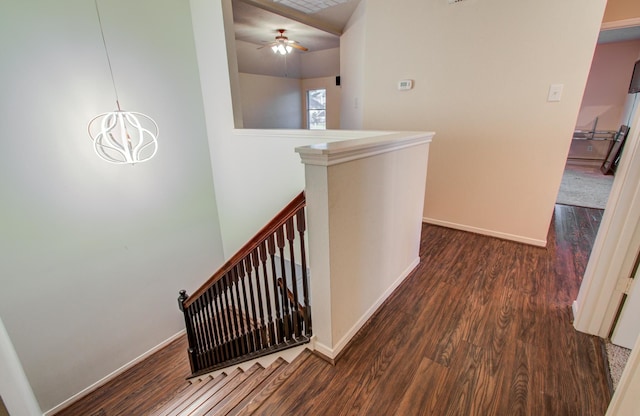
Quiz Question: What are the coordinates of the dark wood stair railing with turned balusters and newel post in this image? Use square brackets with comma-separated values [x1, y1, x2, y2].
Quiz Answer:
[178, 193, 312, 377]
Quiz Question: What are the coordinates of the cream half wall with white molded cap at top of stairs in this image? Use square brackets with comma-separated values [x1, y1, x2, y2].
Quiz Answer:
[296, 133, 433, 359]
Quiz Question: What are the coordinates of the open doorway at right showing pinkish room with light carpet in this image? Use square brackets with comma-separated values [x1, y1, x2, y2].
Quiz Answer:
[557, 32, 640, 209]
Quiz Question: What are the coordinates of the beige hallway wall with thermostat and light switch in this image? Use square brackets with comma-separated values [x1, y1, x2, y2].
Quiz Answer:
[341, 0, 605, 245]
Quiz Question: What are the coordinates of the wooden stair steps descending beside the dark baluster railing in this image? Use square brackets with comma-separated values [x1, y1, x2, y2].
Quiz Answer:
[150, 350, 311, 416]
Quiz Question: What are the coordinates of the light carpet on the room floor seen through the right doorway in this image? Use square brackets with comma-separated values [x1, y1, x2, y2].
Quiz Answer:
[556, 164, 613, 209]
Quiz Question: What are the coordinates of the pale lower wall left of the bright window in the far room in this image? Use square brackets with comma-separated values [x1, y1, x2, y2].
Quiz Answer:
[239, 73, 304, 129]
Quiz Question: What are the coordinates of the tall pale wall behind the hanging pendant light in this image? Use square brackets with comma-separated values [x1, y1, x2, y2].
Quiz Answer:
[0, 0, 228, 410]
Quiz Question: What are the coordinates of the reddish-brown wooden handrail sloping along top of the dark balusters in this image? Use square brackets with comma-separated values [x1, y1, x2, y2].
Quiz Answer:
[184, 191, 307, 307]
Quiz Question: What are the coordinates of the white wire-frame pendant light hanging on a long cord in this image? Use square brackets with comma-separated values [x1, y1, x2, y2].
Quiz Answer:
[88, 0, 159, 165]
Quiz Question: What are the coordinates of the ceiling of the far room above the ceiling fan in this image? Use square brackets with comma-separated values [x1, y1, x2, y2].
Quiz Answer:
[232, 0, 360, 52]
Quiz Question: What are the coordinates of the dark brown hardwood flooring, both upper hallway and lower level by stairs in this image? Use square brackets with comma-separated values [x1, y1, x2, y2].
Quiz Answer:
[52, 205, 610, 416]
